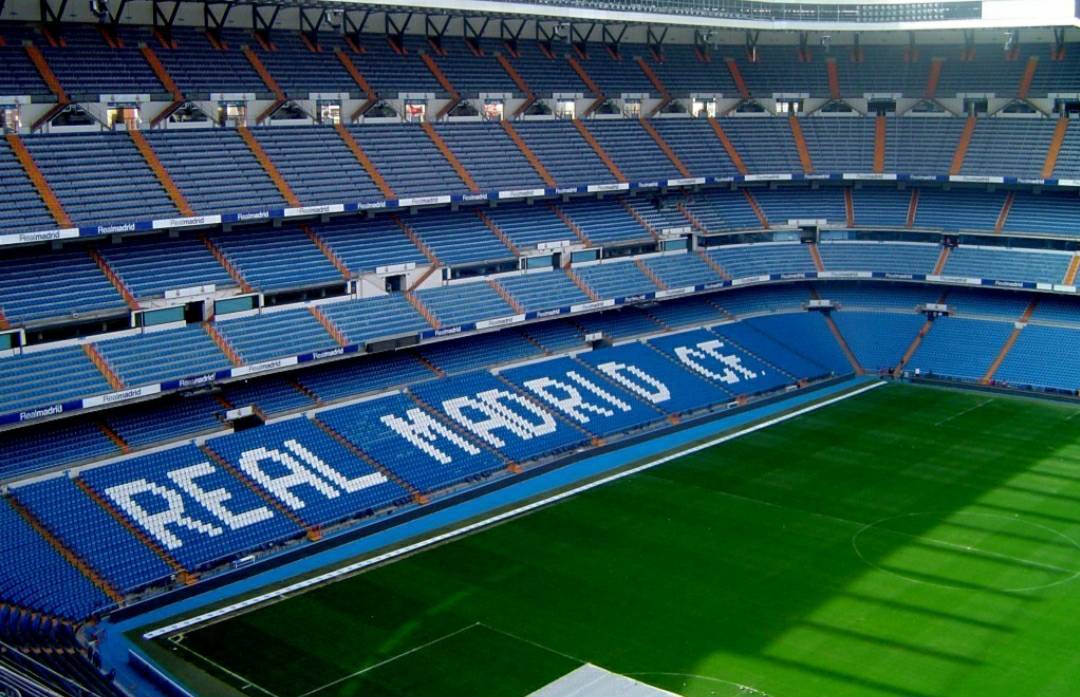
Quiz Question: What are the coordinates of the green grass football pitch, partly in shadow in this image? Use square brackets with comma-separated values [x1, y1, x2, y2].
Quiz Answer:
[161, 385, 1080, 697]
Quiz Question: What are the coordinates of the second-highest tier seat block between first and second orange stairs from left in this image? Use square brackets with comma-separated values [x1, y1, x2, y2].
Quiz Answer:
[23, 133, 179, 225]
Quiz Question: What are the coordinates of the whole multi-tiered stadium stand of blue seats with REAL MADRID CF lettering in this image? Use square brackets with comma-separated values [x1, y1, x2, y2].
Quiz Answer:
[0, 13, 1080, 697]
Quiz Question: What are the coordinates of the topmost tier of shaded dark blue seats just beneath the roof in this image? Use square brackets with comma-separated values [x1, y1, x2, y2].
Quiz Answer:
[6, 23, 1080, 103]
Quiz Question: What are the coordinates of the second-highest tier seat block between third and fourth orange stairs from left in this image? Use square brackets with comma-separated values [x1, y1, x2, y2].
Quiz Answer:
[252, 126, 383, 205]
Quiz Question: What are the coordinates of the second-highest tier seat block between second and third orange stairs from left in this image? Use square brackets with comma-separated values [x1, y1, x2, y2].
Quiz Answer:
[146, 129, 285, 213]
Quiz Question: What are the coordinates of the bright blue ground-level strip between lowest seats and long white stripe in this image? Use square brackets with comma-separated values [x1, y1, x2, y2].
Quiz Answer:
[97, 376, 876, 697]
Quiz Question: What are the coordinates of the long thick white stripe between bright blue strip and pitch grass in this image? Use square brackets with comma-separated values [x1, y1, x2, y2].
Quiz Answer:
[143, 381, 886, 640]
